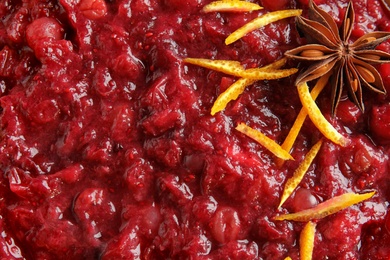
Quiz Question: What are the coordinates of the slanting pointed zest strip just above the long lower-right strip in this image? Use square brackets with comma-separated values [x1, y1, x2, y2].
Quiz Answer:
[279, 140, 322, 208]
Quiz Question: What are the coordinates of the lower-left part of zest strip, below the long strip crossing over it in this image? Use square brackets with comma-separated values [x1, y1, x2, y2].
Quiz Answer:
[211, 78, 255, 116]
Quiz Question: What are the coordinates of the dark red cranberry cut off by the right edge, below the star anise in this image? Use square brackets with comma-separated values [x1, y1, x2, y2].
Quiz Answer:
[370, 104, 390, 144]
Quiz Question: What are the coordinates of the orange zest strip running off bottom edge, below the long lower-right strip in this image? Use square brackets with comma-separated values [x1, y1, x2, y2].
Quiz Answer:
[299, 221, 316, 260]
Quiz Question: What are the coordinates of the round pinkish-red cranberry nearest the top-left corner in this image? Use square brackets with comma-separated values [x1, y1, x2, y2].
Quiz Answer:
[26, 17, 64, 50]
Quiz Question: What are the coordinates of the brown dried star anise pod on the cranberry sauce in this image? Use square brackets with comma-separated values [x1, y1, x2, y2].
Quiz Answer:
[285, 1, 390, 114]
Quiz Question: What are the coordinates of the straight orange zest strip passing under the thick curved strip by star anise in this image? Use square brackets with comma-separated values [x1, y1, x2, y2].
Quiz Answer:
[282, 73, 331, 152]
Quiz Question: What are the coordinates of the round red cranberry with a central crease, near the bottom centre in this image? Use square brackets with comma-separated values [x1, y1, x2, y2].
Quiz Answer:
[211, 207, 241, 244]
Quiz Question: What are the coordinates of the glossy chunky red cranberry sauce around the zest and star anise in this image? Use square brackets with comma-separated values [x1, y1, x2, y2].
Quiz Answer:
[0, 0, 390, 259]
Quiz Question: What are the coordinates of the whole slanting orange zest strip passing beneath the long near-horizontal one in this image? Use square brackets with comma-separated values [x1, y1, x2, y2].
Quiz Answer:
[211, 58, 287, 115]
